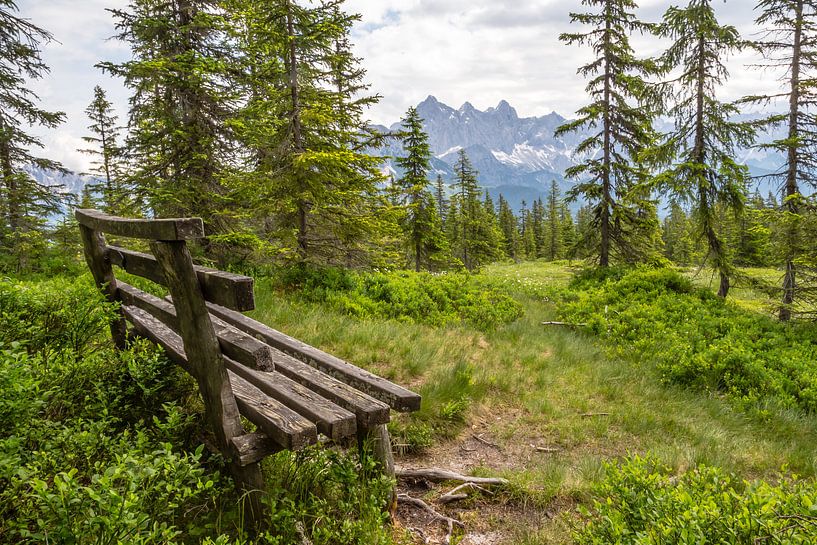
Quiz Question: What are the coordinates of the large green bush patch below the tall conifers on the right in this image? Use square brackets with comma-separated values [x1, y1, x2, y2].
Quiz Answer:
[560, 269, 817, 411]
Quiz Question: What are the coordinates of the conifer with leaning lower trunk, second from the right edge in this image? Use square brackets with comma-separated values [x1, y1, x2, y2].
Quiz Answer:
[658, 0, 753, 297]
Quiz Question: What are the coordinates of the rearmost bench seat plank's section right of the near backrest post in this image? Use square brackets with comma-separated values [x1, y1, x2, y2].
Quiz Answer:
[231, 374, 318, 450]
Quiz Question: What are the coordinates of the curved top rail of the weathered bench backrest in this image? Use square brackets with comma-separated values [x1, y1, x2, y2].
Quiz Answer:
[74, 209, 204, 241]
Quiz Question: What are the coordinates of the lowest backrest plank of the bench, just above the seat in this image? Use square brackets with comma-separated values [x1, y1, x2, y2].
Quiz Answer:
[116, 282, 275, 371]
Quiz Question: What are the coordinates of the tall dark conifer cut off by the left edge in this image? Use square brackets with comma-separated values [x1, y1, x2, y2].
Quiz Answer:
[0, 0, 65, 267]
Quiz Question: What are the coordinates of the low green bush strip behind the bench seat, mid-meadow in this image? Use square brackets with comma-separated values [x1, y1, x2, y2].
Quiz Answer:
[279, 267, 522, 330]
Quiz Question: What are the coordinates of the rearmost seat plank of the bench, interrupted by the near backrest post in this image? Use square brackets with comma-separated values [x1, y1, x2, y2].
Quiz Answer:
[123, 306, 317, 450]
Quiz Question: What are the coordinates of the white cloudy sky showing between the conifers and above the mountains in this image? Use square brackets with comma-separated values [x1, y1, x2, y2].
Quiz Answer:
[18, 0, 779, 171]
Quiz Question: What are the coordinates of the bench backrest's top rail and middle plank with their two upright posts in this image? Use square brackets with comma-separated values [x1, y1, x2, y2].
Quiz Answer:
[75, 209, 254, 468]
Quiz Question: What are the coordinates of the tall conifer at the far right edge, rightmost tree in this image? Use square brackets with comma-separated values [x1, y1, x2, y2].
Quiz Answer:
[743, 0, 817, 314]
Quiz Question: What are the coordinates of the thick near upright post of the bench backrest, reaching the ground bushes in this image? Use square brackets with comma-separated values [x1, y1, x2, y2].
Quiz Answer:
[150, 241, 265, 527]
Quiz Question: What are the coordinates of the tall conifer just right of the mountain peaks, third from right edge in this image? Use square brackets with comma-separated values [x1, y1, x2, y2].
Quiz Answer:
[556, 0, 655, 267]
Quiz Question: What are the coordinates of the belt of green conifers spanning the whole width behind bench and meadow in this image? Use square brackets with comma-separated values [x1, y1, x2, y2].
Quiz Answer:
[0, 0, 817, 320]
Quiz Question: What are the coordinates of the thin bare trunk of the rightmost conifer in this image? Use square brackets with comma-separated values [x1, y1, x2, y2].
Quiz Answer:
[780, 0, 803, 322]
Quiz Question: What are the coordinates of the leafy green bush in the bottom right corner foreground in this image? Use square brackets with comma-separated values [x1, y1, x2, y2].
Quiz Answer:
[574, 457, 817, 545]
